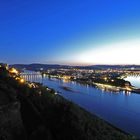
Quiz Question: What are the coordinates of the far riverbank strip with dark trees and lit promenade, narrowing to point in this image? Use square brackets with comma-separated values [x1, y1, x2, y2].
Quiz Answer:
[45, 75, 132, 93]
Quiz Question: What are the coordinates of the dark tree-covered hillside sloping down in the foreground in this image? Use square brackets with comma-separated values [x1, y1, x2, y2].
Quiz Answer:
[0, 68, 135, 140]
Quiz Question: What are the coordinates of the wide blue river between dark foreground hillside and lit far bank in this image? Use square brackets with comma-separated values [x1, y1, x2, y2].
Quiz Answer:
[23, 76, 140, 137]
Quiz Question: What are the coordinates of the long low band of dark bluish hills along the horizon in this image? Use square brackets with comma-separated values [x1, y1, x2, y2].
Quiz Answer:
[10, 63, 140, 71]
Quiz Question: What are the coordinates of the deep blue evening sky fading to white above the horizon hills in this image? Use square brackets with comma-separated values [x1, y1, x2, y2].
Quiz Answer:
[0, 0, 140, 64]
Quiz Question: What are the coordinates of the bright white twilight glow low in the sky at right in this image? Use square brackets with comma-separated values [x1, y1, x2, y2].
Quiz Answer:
[77, 40, 140, 64]
